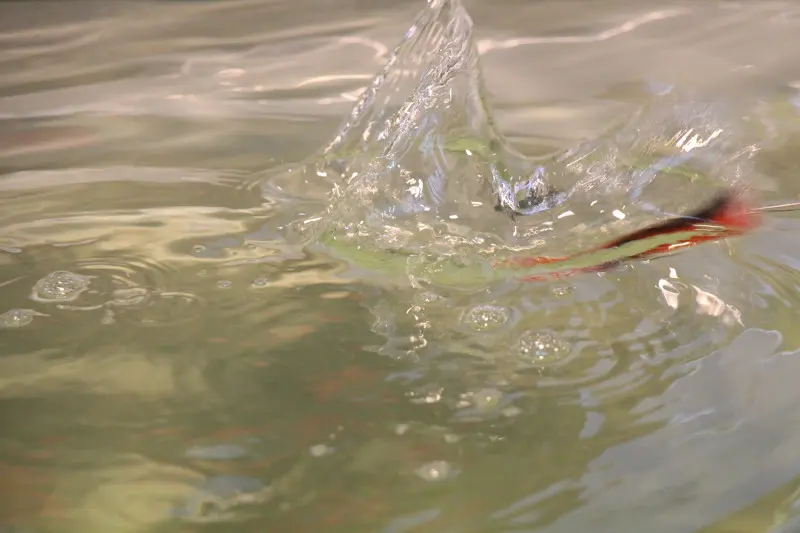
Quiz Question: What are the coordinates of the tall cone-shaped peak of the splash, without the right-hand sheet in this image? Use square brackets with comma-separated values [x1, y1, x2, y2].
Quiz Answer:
[264, 0, 561, 251]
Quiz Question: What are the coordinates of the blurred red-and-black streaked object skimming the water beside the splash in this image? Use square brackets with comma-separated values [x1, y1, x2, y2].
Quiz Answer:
[496, 190, 764, 281]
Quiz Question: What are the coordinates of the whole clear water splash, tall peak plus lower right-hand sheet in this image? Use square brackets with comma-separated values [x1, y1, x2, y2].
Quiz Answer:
[263, 0, 755, 285]
